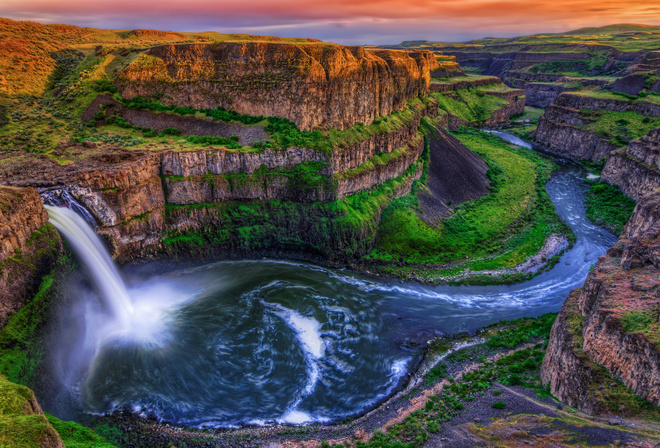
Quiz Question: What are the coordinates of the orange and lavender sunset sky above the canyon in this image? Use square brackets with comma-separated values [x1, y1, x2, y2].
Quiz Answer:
[0, 0, 660, 44]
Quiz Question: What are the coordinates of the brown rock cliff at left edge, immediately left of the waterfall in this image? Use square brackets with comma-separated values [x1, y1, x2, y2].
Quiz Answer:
[0, 187, 61, 327]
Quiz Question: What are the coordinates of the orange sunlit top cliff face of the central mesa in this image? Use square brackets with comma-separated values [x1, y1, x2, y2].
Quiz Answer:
[115, 43, 439, 130]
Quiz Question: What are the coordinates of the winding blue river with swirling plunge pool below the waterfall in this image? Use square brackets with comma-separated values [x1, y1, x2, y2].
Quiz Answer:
[51, 133, 615, 427]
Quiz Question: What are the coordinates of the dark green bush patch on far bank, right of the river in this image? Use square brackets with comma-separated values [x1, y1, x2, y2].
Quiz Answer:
[585, 183, 635, 236]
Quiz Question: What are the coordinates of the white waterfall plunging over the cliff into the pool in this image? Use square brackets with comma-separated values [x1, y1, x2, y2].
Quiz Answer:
[45, 205, 133, 327]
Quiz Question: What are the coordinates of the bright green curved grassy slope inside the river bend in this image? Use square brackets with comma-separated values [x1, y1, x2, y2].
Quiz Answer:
[367, 129, 568, 275]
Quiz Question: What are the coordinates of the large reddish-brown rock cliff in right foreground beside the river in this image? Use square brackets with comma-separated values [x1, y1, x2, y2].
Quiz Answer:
[541, 193, 660, 413]
